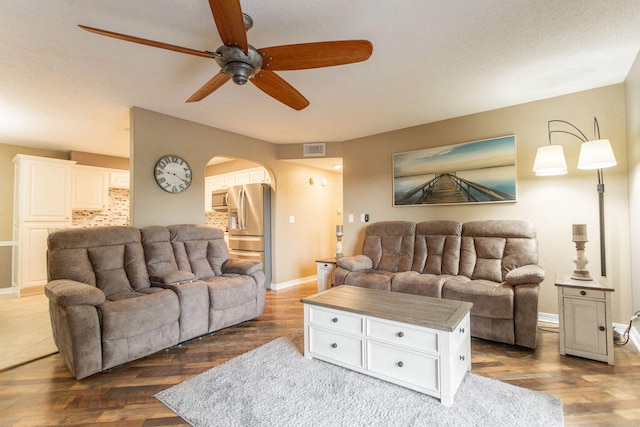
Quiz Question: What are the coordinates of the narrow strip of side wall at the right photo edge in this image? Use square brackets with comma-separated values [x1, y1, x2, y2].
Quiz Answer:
[625, 54, 640, 316]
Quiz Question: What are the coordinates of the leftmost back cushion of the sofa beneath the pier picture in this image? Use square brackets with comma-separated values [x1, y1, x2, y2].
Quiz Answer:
[362, 221, 416, 273]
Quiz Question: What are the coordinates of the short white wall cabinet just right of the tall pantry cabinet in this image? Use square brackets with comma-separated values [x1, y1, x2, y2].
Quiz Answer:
[72, 165, 111, 210]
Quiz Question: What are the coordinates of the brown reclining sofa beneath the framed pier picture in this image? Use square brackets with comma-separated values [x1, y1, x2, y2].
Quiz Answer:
[334, 220, 544, 348]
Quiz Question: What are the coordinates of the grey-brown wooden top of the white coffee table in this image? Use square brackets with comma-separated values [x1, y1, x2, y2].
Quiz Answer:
[300, 285, 473, 332]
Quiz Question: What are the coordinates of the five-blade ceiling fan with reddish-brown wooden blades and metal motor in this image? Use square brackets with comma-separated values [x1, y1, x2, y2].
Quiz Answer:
[79, 0, 373, 110]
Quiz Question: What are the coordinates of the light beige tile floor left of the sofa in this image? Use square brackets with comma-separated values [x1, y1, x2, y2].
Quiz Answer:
[0, 295, 58, 370]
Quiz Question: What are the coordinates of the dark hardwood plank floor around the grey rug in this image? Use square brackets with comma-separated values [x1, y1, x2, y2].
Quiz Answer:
[0, 282, 640, 426]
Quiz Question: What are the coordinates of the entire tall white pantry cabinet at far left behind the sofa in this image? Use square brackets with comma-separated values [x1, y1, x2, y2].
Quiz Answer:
[12, 154, 75, 295]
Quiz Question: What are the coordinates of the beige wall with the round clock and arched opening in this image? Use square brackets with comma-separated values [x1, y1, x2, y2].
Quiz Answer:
[131, 107, 342, 284]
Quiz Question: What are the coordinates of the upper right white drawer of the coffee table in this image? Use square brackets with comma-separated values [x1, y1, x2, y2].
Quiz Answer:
[367, 318, 438, 355]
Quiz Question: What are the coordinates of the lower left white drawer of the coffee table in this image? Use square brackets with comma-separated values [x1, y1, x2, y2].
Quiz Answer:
[309, 326, 364, 369]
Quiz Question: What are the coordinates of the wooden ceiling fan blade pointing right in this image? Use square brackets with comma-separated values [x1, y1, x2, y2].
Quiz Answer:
[258, 40, 373, 71]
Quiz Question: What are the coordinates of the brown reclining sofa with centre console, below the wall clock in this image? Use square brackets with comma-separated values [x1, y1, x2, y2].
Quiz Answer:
[45, 225, 265, 379]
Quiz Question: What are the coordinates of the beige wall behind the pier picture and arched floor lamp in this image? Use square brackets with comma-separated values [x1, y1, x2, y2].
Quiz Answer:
[343, 84, 631, 323]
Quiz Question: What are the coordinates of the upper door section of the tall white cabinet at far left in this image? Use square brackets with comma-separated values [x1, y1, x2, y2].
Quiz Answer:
[13, 154, 75, 222]
